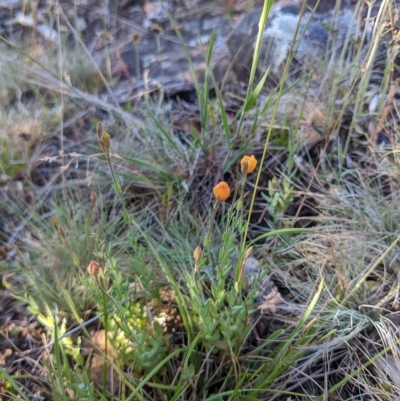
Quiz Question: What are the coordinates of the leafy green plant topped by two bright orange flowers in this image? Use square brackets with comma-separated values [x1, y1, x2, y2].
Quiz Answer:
[187, 169, 257, 355]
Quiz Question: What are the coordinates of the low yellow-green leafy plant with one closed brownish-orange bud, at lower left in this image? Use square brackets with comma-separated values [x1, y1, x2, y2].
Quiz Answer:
[84, 242, 169, 375]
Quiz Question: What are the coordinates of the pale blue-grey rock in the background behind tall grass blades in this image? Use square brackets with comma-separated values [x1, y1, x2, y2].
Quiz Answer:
[227, 0, 357, 80]
